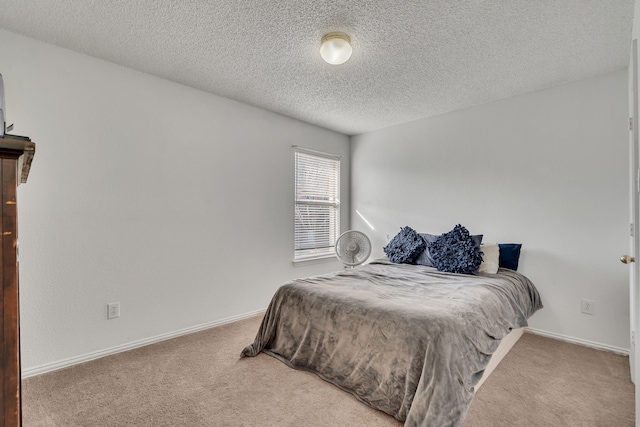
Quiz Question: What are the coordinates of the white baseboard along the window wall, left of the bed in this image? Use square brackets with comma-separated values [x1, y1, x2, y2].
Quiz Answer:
[22, 309, 266, 379]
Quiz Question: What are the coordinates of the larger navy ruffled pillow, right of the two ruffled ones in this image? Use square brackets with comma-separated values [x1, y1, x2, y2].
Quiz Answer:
[428, 224, 482, 274]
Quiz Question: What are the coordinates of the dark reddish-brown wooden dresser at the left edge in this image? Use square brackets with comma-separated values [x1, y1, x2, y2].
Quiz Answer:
[0, 135, 36, 427]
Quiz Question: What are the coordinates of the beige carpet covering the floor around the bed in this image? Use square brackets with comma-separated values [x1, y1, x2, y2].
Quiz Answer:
[23, 317, 634, 427]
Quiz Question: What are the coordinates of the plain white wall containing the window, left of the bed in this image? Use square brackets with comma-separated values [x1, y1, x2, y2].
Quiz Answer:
[0, 31, 349, 371]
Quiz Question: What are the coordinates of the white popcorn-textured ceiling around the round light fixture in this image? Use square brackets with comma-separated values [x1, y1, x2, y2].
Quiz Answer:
[0, 0, 634, 135]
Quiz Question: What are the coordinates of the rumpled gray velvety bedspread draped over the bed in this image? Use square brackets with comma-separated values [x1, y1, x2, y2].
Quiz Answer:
[241, 260, 542, 427]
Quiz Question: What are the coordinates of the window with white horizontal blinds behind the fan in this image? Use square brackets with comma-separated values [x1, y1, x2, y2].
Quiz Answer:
[294, 147, 340, 261]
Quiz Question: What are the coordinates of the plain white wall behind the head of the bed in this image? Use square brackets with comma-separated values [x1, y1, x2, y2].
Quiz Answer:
[351, 70, 629, 349]
